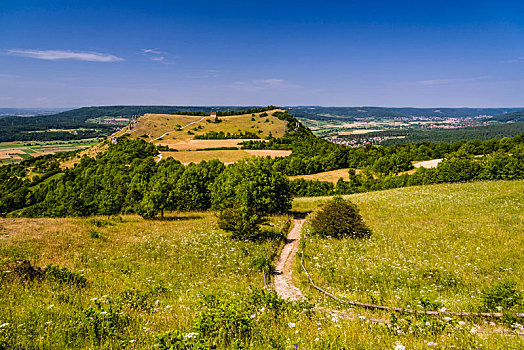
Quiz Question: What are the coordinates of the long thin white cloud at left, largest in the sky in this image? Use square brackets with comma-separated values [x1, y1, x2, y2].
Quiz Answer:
[7, 49, 124, 62]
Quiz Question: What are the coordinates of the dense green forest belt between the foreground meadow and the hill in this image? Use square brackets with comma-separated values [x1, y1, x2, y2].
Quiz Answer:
[0, 112, 524, 217]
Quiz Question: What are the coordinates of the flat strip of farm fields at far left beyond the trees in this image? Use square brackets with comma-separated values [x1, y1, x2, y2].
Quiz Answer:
[0, 139, 98, 165]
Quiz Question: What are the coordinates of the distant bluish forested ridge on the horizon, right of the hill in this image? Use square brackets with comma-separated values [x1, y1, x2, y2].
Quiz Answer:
[286, 106, 524, 120]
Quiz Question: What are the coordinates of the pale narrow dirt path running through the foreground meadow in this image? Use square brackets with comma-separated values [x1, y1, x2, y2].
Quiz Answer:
[275, 219, 306, 301]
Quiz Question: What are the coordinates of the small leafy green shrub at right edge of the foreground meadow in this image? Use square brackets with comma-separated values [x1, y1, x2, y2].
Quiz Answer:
[482, 280, 523, 311]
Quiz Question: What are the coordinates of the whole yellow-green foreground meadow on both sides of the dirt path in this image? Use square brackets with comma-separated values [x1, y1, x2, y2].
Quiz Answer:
[0, 181, 524, 349]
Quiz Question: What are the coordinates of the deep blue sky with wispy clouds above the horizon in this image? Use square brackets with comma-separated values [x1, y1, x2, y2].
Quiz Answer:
[0, 0, 524, 107]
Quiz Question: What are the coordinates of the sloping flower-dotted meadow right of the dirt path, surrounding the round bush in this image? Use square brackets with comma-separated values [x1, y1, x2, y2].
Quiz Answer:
[294, 181, 524, 312]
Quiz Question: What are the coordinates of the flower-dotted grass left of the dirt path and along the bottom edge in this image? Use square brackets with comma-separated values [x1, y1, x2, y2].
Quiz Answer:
[0, 205, 523, 349]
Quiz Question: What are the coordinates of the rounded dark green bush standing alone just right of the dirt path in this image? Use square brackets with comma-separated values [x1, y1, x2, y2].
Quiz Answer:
[311, 197, 371, 238]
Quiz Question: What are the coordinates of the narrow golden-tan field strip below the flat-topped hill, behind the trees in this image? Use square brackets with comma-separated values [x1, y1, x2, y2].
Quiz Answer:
[162, 149, 291, 164]
